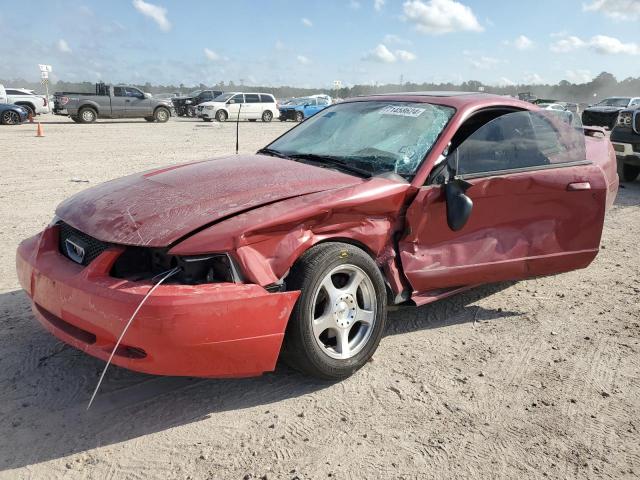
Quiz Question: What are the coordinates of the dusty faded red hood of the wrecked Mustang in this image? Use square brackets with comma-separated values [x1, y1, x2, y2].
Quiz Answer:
[56, 155, 363, 247]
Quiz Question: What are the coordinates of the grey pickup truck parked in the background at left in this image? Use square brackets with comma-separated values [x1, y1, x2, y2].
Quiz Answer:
[53, 83, 172, 123]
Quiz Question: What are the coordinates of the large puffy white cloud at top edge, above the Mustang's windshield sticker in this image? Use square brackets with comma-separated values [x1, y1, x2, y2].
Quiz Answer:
[403, 0, 483, 35]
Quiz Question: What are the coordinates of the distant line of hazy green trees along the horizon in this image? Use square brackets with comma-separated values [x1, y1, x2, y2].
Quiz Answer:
[0, 72, 640, 103]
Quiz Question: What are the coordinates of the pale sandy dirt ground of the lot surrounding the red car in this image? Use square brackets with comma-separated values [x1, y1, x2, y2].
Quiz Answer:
[0, 117, 640, 479]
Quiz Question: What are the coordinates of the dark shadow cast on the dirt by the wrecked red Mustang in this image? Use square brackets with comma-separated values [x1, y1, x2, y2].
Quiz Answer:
[0, 284, 518, 471]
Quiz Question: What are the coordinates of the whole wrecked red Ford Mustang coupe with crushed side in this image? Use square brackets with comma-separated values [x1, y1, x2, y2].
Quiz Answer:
[17, 92, 618, 379]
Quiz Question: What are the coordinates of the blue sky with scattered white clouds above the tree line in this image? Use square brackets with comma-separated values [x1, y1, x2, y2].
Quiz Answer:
[0, 0, 640, 88]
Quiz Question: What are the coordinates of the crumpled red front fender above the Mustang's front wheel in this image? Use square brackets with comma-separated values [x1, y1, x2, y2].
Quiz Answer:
[170, 178, 411, 293]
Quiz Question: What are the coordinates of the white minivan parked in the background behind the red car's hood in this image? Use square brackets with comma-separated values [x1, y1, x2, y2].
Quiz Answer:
[197, 92, 278, 122]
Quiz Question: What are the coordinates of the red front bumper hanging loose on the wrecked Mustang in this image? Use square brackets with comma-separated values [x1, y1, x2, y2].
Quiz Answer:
[16, 227, 299, 377]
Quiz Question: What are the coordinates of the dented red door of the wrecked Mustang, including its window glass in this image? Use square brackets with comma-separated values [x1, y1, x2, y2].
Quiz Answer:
[399, 111, 607, 296]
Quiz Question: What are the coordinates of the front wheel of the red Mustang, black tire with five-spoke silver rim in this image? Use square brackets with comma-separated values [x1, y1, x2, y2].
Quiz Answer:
[282, 243, 387, 380]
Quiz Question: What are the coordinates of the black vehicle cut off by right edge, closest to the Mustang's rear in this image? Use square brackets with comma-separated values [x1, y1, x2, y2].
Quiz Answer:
[611, 107, 640, 182]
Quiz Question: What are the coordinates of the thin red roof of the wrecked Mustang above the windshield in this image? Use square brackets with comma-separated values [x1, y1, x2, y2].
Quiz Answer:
[345, 91, 534, 110]
